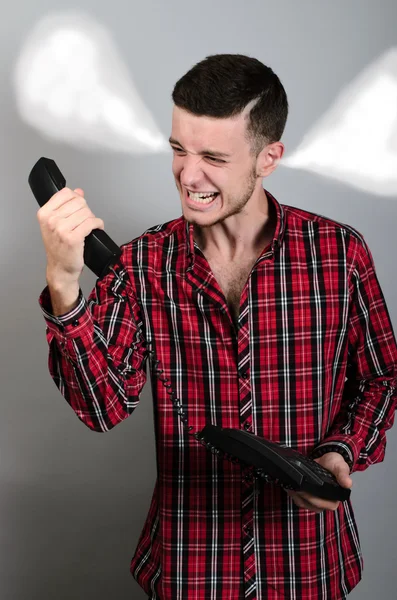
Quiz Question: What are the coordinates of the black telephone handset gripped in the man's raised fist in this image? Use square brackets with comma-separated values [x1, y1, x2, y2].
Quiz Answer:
[28, 157, 121, 277]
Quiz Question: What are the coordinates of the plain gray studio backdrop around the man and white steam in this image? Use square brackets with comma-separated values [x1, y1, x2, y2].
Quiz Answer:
[0, 0, 397, 600]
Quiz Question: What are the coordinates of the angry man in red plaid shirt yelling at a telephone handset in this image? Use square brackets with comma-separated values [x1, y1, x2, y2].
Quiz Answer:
[38, 55, 397, 600]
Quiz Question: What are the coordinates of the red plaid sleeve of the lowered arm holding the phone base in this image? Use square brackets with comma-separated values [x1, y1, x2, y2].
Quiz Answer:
[311, 234, 397, 472]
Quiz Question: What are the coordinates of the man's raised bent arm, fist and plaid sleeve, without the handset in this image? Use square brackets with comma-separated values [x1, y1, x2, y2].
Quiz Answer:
[38, 188, 146, 431]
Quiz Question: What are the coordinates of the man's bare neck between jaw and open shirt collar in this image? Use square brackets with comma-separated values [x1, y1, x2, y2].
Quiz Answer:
[193, 188, 277, 261]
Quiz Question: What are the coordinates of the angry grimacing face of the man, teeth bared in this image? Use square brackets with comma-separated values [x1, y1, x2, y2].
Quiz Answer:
[170, 106, 262, 227]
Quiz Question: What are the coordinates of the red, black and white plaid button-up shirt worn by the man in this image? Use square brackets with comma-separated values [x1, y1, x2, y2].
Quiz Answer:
[39, 192, 397, 600]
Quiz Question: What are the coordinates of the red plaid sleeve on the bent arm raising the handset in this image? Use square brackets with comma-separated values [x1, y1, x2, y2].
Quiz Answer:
[39, 253, 147, 432]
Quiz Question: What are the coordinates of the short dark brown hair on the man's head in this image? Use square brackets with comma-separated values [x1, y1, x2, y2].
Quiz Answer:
[172, 54, 288, 155]
